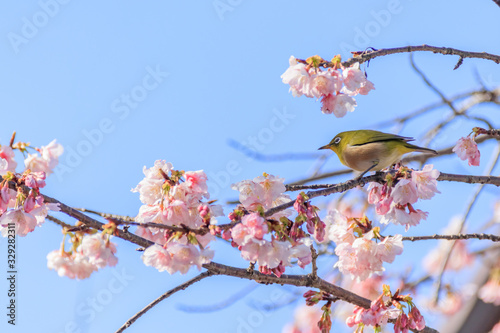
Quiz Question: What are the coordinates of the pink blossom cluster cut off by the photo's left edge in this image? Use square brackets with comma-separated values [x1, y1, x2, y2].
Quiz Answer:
[0, 140, 63, 237]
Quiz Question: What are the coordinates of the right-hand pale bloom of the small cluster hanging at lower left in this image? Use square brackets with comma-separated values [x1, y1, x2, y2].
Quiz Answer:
[78, 234, 118, 268]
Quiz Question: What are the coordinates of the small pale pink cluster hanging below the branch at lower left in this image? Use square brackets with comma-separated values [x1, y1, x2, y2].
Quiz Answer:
[47, 233, 118, 280]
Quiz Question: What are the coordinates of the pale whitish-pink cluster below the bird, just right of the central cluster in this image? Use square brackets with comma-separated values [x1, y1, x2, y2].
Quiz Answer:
[325, 210, 403, 282]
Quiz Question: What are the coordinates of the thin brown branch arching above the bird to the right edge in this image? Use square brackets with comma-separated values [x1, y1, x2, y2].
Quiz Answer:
[340, 44, 500, 67]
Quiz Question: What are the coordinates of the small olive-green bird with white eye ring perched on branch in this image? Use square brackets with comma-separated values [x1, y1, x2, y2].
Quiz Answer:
[318, 130, 438, 178]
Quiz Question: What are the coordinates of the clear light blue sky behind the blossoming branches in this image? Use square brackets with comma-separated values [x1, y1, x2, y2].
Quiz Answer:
[0, 0, 500, 333]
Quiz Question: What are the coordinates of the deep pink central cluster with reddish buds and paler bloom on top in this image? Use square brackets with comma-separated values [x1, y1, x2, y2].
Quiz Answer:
[228, 174, 312, 277]
